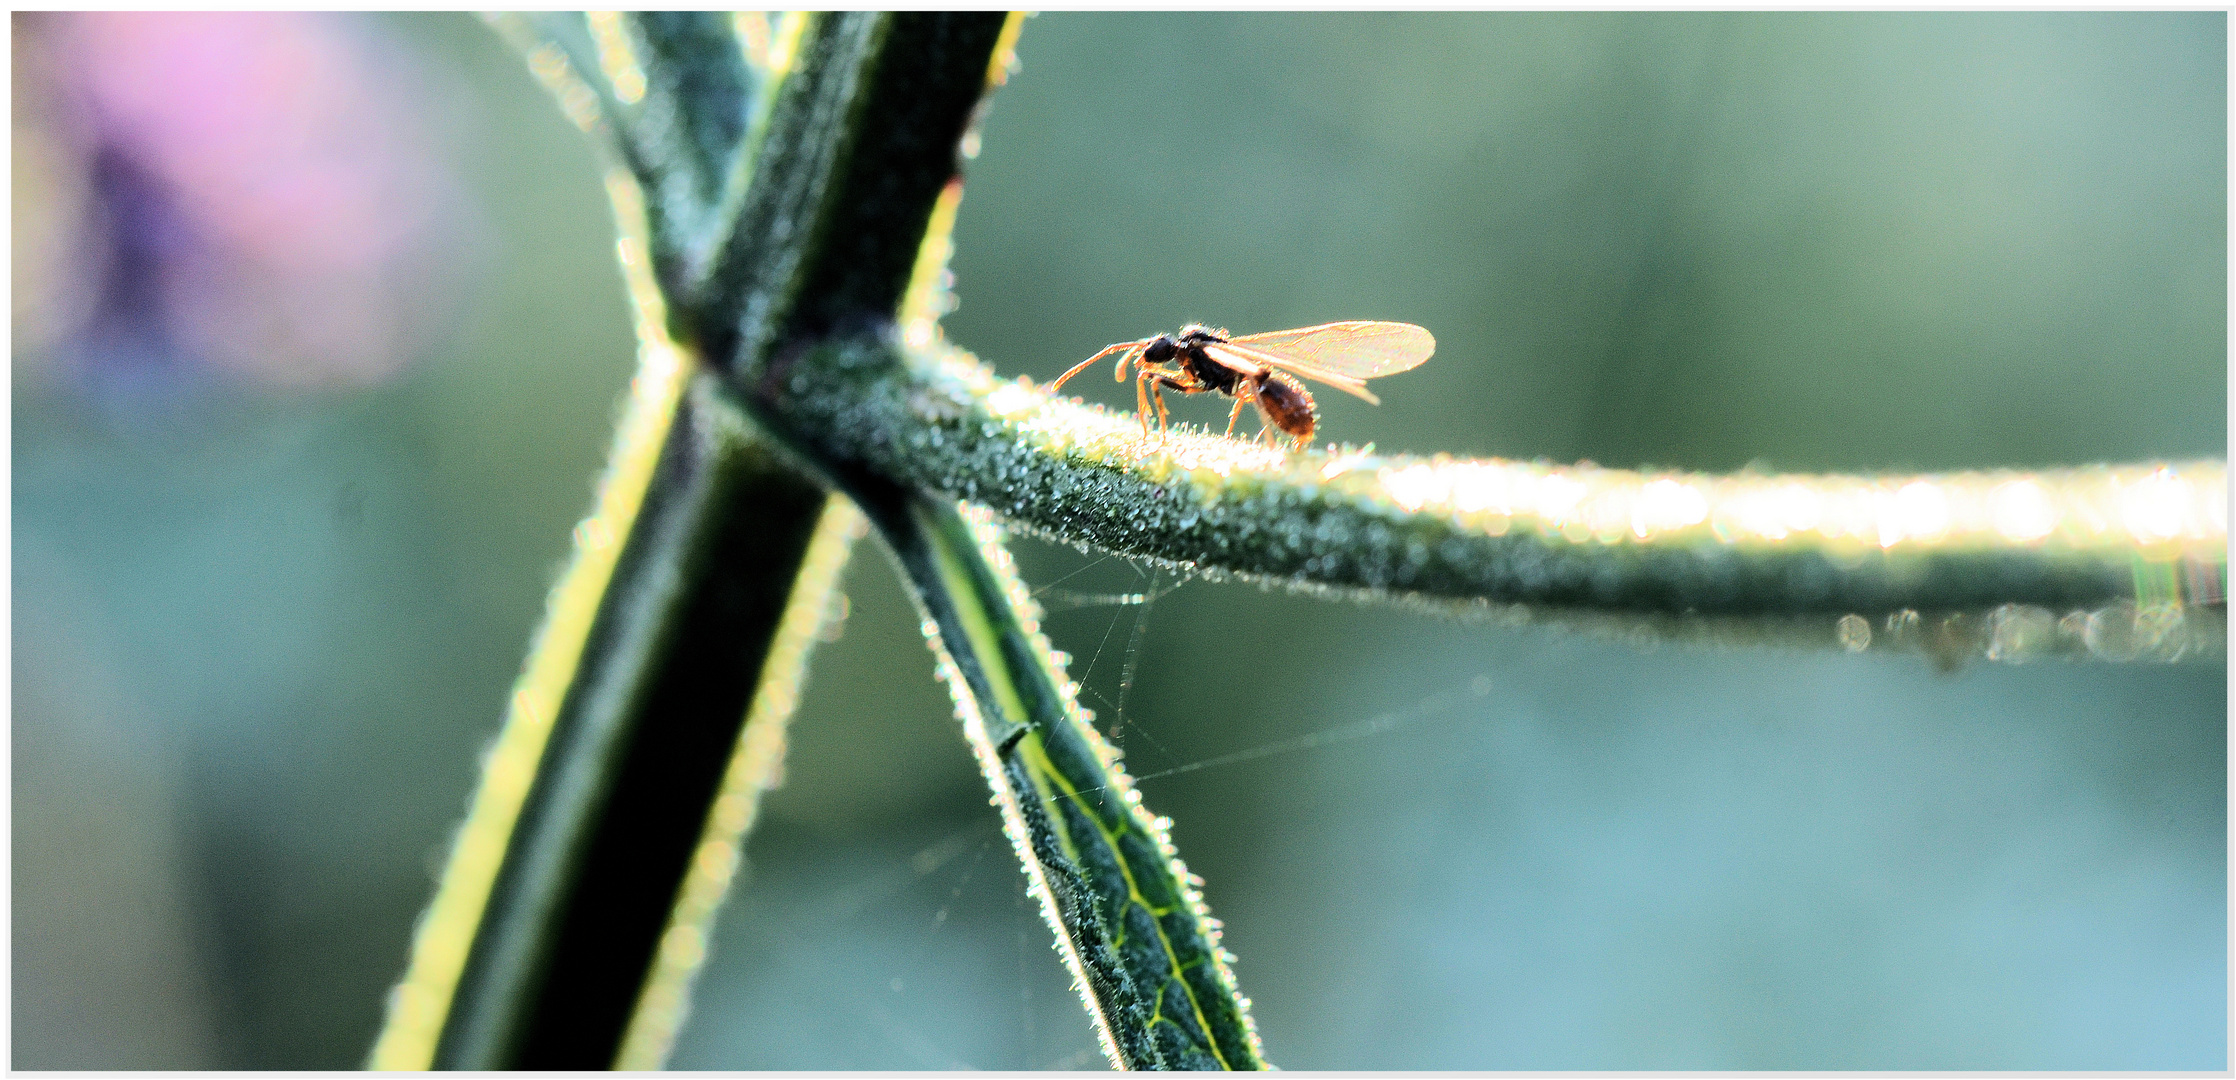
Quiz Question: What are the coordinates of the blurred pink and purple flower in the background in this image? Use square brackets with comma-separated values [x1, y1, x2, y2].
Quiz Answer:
[24, 11, 472, 387]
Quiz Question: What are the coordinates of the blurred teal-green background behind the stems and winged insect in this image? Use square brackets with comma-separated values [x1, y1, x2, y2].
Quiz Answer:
[11, 13, 2227, 1069]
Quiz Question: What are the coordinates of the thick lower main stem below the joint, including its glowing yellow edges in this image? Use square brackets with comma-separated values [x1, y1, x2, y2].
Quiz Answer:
[371, 321, 850, 1069]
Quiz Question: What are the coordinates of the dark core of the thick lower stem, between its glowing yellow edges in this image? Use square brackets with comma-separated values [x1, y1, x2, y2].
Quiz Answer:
[434, 376, 827, 1069]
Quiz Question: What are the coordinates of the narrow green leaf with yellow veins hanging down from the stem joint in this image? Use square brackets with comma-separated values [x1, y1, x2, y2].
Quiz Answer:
[863, 487, 1266, 1069]
